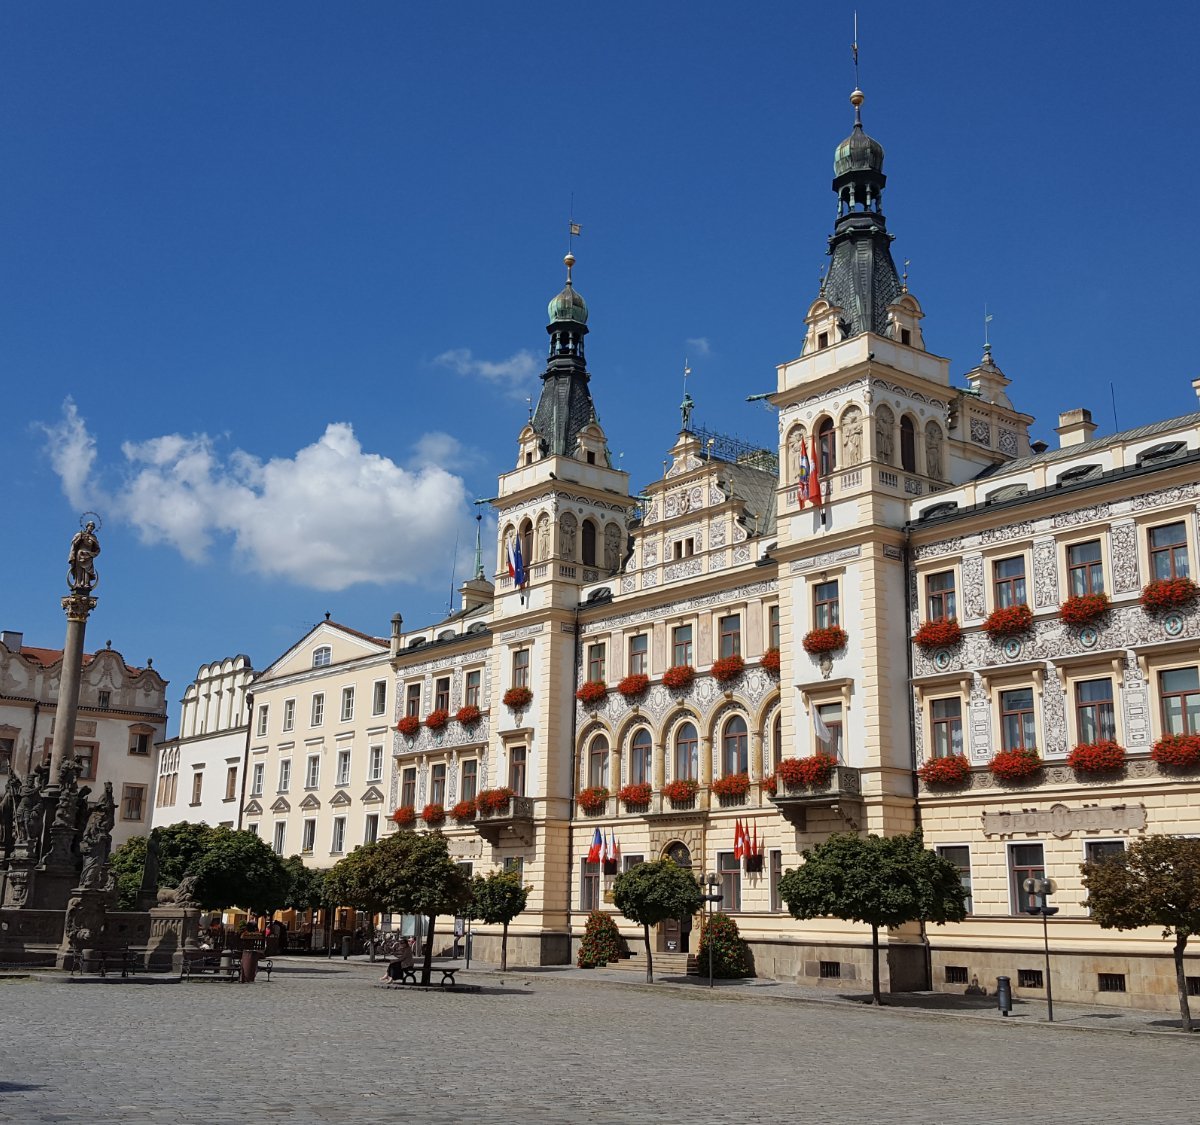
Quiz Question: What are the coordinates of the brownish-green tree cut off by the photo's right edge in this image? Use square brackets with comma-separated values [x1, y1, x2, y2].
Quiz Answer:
[1081, 836, 1200, 1031]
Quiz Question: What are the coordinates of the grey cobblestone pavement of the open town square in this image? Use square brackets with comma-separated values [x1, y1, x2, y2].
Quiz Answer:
[0, 958, 1200, 1125]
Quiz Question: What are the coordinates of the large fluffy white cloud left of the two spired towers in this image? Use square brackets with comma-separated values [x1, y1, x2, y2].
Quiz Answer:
[44, 402, 466, 590]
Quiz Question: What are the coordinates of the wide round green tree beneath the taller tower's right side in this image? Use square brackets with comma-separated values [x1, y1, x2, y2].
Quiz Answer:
[779, 829, 966, 1004]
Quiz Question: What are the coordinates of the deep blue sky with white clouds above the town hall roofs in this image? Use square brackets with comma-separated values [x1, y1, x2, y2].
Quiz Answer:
[0, 2, 1200, 730]
